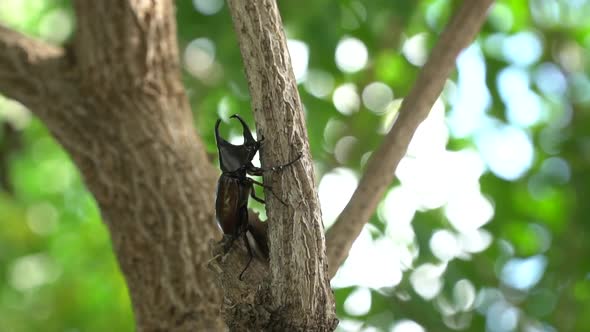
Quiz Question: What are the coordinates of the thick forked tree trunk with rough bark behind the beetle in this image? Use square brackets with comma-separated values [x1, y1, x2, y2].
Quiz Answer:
[0, 0, 225, 331]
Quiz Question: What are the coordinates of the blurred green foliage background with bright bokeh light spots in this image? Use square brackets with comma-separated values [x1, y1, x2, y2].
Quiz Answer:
[0, 0, 590, 332]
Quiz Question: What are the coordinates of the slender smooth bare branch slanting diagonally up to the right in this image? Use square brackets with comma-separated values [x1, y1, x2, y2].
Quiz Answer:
[326, 0, 493, 276]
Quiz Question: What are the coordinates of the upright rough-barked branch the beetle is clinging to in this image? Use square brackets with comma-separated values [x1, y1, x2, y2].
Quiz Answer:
[228, 0, 336, 331]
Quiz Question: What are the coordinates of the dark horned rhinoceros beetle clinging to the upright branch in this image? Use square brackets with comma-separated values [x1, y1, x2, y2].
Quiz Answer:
[215, 114, 301, 280]
